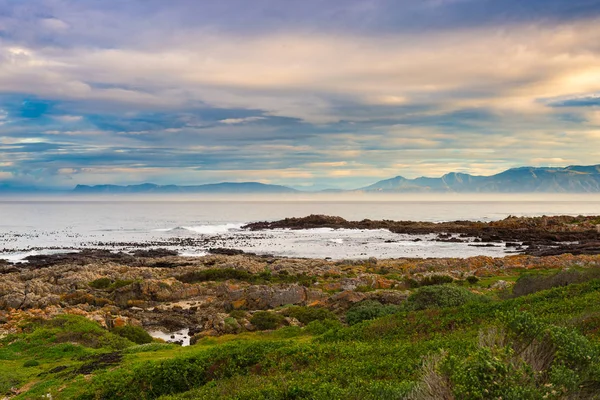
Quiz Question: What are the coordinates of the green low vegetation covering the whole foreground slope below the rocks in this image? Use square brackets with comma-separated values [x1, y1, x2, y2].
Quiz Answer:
[0, 275, 600, 400]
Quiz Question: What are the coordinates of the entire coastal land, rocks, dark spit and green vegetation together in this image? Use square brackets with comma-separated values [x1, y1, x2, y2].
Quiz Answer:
[0, 216, 600, 400]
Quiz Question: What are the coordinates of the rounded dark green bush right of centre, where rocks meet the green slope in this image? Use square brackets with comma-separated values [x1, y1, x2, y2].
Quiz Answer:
[406, 285, 480, 310]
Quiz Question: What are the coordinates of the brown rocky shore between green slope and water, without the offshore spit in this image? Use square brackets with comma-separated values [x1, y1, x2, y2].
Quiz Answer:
[0, 242, 600, 344]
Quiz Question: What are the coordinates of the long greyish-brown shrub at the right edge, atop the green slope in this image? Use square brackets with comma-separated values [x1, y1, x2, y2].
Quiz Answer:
[513, 268, 600, 297]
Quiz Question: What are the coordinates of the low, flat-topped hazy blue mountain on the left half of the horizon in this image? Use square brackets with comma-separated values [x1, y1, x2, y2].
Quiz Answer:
[73, 182, 297, 194]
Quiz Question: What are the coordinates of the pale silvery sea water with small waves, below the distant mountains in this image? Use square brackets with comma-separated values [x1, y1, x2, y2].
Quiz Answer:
[0, 195, 600, 260]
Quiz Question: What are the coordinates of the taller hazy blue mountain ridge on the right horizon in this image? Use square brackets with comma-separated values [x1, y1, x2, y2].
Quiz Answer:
[358, 165, 600, 193]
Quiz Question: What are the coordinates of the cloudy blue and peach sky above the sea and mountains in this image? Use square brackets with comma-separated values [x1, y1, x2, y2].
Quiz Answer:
[0, 0, 600, 189]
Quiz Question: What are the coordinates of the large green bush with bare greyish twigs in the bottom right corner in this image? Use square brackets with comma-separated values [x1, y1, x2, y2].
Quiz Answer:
[444, 312, 600, 400]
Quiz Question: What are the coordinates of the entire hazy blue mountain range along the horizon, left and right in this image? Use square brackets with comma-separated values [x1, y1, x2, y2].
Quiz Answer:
[0, 165, 600, 194]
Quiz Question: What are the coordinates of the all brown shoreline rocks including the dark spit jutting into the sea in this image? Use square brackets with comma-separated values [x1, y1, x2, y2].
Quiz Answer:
[0, 215, 600, 344]
